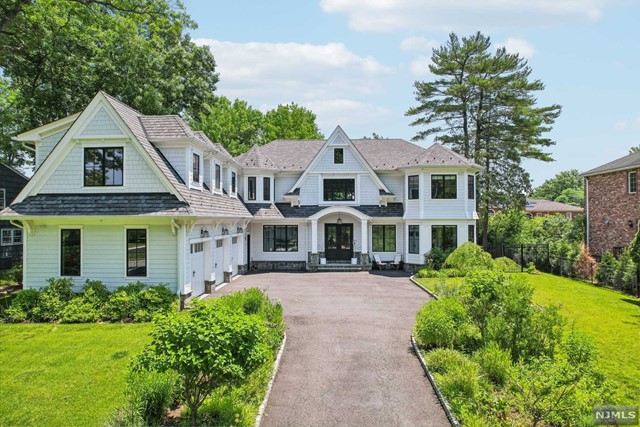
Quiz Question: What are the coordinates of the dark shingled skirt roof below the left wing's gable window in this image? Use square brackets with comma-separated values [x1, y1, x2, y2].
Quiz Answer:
[2, 193, 189, 216]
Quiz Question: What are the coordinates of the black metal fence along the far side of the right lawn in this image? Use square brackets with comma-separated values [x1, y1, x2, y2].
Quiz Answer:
[487, 245, 640, 296]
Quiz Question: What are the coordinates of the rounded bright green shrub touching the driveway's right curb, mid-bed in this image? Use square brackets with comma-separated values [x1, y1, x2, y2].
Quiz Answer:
[414, 298, 469, 348]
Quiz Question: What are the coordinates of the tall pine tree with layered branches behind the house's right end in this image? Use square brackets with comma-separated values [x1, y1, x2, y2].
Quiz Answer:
[406, 32, 561, 246]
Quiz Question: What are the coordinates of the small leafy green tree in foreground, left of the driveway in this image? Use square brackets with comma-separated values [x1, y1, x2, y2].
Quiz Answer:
[132, 304, 271, 425]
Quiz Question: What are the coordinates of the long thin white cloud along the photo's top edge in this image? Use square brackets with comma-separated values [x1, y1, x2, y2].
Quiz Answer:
[320, 0, 617, 32]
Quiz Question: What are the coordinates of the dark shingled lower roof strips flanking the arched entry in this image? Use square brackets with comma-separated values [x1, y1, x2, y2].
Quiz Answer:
[247, 203, 404, 219]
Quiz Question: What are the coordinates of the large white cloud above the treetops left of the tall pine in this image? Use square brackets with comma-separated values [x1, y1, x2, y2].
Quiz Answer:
[194, 39, 395, 133]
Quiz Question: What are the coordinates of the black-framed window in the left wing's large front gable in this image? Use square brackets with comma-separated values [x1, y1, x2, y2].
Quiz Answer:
[84, 147, 124, 187]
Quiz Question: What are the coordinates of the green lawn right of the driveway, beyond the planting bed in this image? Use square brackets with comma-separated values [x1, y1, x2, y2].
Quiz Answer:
[418, 274, 640, 404]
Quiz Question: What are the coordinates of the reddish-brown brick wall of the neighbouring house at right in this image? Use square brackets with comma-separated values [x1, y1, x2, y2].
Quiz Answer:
[588, 171, 640, 256]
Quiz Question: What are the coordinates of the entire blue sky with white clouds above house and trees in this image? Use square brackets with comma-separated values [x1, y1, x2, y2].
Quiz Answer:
[180, 0, 640, 185]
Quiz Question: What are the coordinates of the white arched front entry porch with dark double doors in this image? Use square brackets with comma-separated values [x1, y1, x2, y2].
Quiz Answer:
[307, 205, 371, 271]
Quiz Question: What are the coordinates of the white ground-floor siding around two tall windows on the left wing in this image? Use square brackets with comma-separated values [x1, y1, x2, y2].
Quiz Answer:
[25, 223, 178, 291]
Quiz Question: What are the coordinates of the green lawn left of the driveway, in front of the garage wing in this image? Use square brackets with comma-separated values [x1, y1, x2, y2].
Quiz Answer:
[0, 323, 151, 426]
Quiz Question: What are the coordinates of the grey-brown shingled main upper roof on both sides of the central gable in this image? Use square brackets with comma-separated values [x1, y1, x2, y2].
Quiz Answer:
[237, 139, 480, 171]
